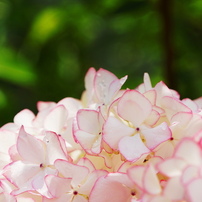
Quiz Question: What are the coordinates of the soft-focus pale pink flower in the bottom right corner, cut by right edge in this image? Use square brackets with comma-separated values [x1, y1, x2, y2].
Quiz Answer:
[158, 138, 202, 202]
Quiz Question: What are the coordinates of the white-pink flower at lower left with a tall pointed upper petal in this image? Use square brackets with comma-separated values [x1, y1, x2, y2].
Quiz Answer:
[3, 127, 69, 196]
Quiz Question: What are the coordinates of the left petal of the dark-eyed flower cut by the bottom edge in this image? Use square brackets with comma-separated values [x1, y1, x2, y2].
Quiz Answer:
[45, 175, 71, 197]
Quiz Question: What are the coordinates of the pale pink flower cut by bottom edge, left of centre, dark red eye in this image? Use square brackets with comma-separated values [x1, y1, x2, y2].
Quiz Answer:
[45, 159, 107, 202]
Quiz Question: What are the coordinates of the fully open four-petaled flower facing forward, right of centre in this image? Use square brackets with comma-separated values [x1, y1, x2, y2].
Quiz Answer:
[103, 90, 171, 161]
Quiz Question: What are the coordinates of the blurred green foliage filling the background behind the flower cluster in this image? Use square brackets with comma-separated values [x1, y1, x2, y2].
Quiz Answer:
[0, 0, 202, 125]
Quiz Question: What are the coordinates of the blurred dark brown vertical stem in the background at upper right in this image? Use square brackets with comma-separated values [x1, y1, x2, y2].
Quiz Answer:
[159, 0, 177, 90]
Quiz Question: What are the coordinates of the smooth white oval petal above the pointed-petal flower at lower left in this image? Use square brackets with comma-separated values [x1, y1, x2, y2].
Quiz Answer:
[44, 105, 68, 134]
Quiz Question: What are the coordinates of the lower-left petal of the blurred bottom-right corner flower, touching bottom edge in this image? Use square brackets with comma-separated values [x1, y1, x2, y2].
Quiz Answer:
[163, 177, 185, 201]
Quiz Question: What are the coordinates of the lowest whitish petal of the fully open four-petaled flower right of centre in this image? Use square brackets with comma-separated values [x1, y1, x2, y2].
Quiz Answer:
[118, 134, 150, 161]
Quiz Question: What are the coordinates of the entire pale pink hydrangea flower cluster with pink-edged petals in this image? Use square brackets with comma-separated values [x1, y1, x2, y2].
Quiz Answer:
[0, 68, 202, 202]
